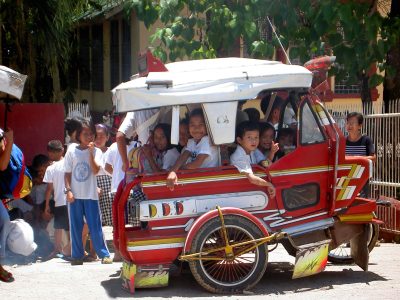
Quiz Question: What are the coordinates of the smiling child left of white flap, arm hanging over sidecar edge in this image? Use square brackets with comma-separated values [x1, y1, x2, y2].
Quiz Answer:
[167, 108, 219, 191]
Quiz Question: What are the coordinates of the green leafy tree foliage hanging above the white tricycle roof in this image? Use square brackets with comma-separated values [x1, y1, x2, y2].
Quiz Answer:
[128, 0, 400, 101]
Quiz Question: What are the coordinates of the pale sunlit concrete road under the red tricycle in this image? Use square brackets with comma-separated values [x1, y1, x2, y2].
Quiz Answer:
[0, 238, 400, 300]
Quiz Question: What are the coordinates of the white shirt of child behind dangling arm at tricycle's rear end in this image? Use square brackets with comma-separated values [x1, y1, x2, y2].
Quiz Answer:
[105, 142, 138, 193]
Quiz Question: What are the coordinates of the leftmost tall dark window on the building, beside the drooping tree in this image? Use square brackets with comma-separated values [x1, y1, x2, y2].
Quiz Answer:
[79, 26, 90, 90]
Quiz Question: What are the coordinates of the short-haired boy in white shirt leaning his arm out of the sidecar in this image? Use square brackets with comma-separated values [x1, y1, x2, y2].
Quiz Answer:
[231, 121, 275, 197]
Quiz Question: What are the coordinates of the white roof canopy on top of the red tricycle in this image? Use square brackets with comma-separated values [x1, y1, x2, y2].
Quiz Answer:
[112, 58, 312, 112]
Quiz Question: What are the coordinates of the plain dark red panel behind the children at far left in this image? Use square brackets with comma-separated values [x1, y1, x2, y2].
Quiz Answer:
[0, 103, 64, 165]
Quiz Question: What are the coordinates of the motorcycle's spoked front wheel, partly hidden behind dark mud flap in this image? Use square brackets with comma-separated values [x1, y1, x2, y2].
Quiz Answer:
[328, 224, 379, 264]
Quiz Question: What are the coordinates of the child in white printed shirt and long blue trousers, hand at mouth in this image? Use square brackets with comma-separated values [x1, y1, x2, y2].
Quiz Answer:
[64, 120, 112, 265]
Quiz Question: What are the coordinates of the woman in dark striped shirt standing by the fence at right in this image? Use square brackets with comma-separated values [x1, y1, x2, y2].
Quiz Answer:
[346, 112, 376, 198]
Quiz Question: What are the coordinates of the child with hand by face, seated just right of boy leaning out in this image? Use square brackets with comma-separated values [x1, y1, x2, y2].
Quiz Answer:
[255, 122, 279, 165]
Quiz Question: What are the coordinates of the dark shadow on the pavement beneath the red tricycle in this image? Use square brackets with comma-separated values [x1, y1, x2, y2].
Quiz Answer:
[101, 262, 387, 298]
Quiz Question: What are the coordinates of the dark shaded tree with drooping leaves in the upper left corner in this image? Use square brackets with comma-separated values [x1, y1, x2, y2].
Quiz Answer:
[0, 0, 107, 102]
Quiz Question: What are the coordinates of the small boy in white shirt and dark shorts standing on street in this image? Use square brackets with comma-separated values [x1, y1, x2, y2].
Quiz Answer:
[43, 140, 71, 258]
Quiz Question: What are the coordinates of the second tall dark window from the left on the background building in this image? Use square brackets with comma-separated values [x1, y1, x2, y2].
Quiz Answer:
[92, 24, 104, 92]
